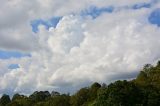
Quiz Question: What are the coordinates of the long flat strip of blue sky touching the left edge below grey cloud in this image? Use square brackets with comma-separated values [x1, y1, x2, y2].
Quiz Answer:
[0, 50, 31, 59]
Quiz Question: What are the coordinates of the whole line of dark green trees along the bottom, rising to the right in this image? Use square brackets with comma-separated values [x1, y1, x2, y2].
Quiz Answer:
[0, 61, 160, 106]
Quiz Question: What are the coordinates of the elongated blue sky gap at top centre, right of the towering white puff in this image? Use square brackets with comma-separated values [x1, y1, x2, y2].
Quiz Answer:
[80, 6, 114, 19]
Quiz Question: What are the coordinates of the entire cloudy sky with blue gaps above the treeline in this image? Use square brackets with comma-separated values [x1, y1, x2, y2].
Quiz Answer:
[0, 0, 160, 95]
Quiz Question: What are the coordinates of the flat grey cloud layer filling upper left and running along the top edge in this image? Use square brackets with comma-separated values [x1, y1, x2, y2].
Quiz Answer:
[0, 0, 154, 52]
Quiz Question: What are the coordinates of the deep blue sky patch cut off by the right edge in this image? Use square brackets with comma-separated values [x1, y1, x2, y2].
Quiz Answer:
[148, 8, 160, 27]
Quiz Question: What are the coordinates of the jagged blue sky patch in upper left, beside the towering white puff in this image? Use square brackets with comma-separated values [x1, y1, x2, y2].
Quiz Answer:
[31, 17, 62, 33]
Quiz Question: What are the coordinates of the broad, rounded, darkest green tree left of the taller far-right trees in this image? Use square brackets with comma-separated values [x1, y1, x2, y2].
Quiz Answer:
[95, 81, 141, 106]
